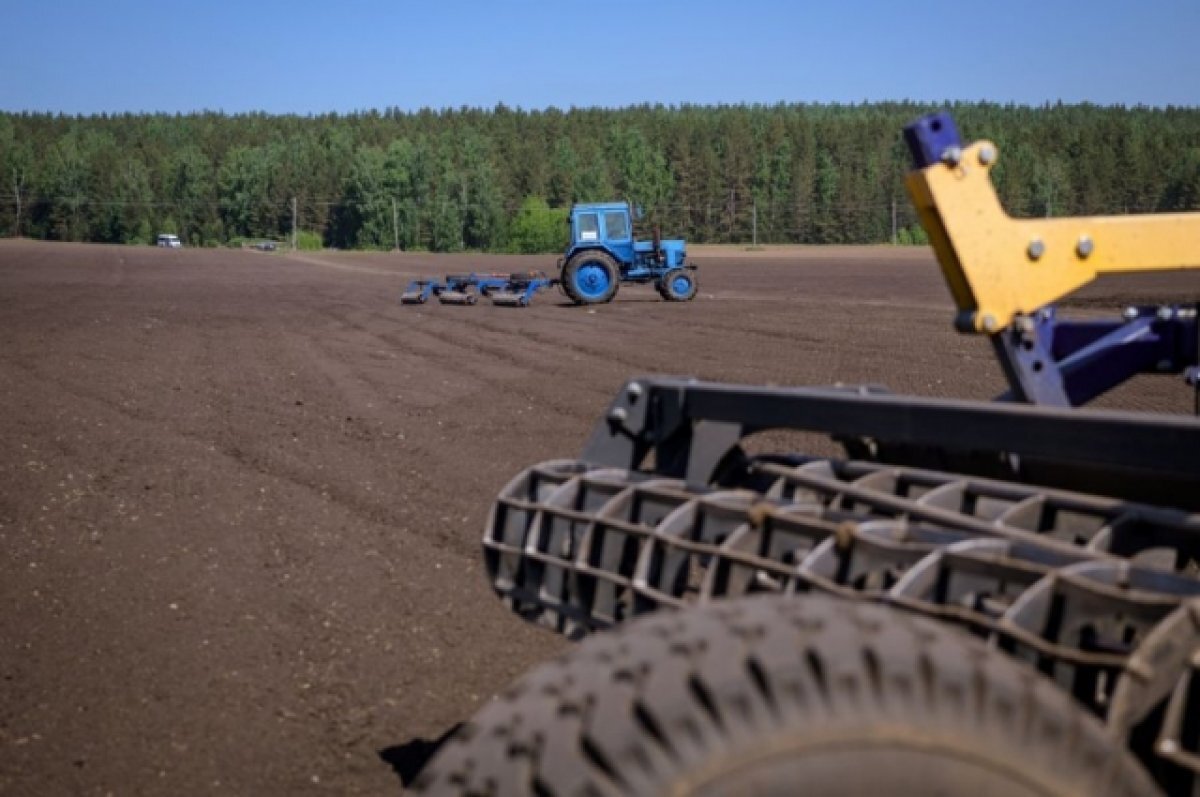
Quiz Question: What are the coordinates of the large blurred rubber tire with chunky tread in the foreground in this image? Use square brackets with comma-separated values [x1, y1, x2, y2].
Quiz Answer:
[414, 597, 1159, 797]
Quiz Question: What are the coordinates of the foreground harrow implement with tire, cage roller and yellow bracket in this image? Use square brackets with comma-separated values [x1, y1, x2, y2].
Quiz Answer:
[415, 114, 1200, 797]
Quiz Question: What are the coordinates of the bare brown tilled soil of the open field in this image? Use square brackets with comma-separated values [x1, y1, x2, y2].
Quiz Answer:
[0, 241, 1200, 795]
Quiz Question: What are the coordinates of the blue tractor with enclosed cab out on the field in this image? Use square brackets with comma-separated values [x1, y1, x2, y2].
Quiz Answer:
[558, 202, 697, 305]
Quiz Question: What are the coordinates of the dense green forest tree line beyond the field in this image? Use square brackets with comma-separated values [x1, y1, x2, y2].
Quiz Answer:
[0, 103, 1200, 251]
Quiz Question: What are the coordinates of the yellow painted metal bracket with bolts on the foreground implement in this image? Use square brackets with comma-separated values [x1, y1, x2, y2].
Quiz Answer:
[907, 142, 1200, 334]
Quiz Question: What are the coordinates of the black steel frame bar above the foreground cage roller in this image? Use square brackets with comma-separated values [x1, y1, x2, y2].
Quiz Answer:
[582, 378, 1200, 503]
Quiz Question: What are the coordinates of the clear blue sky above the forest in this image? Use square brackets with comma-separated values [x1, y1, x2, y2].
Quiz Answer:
[0, 0, 1200, 114]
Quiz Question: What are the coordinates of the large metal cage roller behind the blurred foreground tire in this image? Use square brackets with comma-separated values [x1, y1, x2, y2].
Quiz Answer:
[484, 460, 1200, 793]
